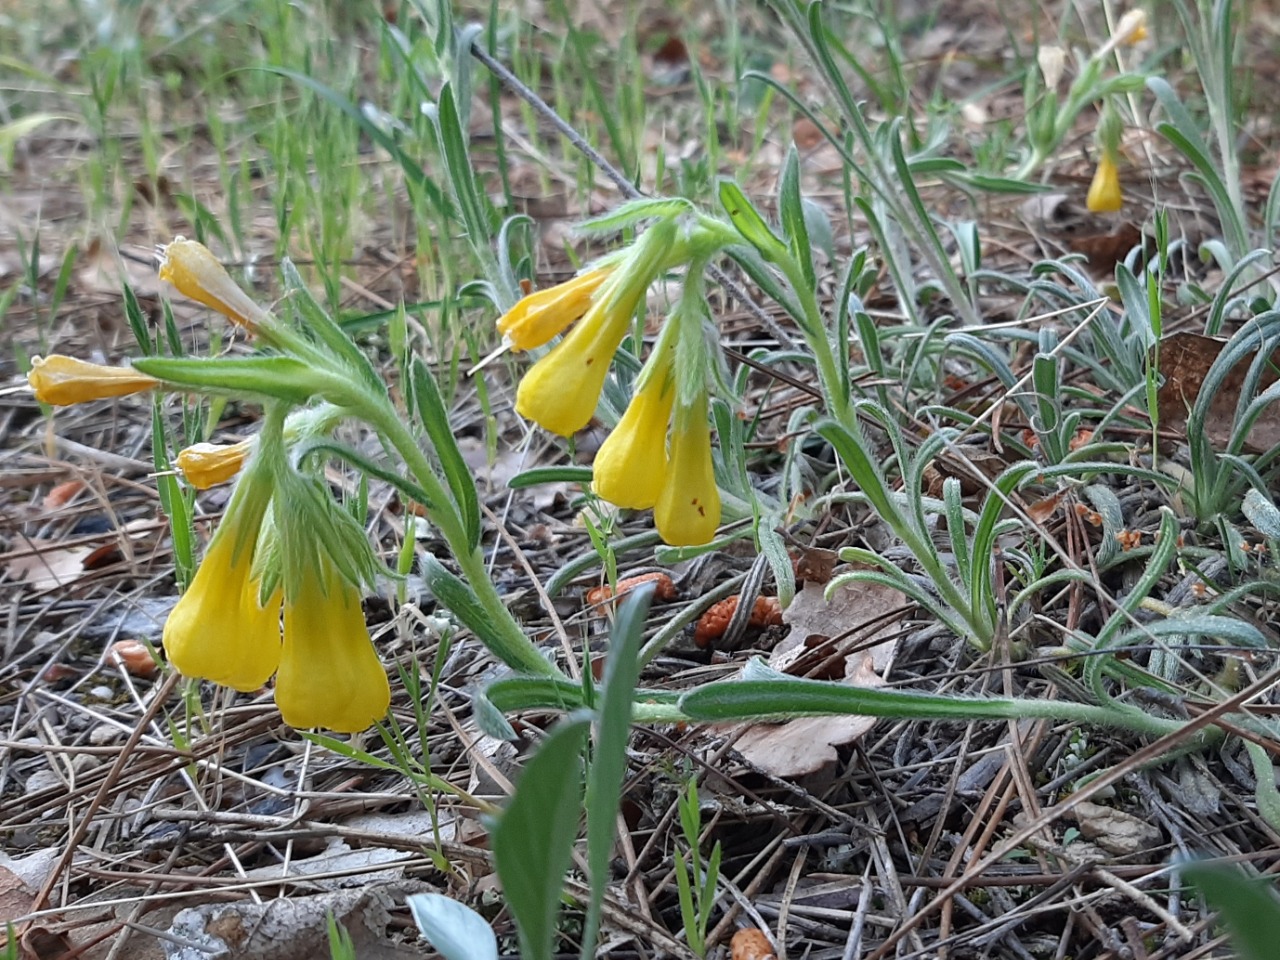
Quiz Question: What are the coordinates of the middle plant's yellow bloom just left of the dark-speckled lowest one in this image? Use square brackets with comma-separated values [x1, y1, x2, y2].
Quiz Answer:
[591, 347, 676, 509]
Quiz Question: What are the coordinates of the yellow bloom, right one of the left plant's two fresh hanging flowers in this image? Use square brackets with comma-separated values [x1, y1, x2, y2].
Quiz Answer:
[275, 554, 392, 733]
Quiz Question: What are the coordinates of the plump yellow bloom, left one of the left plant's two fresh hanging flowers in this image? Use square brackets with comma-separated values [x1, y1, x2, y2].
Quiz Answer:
[164, 513, 280, 691]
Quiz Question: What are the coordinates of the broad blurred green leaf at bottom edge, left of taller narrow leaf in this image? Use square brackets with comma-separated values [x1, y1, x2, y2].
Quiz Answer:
[493, 718, 590, 960]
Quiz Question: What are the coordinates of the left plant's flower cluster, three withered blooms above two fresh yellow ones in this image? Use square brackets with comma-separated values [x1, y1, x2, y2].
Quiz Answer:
[27, 237, 390, 732]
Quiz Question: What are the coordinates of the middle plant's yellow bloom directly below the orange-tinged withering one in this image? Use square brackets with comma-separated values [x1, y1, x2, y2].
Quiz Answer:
[516, 289, 644, 436]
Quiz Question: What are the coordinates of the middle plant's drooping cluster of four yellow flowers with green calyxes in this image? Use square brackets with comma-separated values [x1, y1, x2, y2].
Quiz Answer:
[498, 219, 721, 545]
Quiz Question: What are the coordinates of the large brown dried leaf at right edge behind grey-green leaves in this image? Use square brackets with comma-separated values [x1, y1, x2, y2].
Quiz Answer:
[1157, 333, 1280, 453]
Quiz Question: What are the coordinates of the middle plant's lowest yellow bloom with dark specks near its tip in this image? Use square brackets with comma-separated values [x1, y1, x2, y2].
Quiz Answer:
[653, 396, 721, 547]
